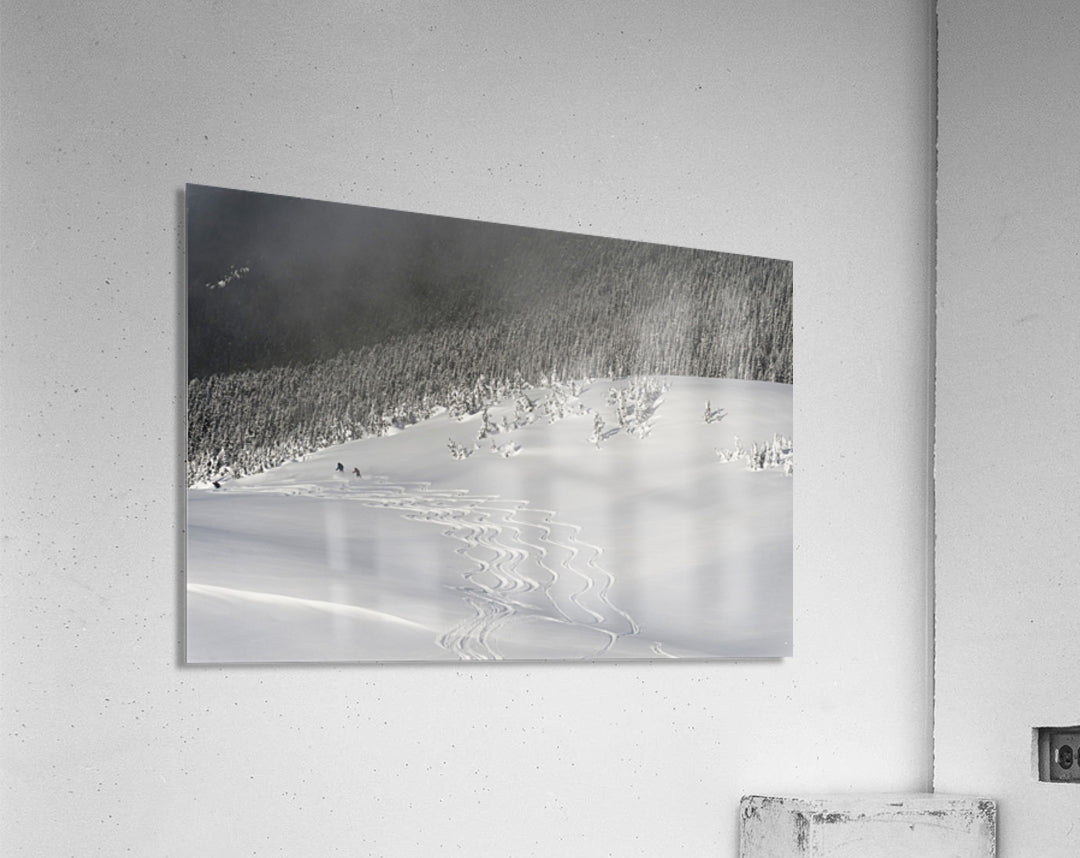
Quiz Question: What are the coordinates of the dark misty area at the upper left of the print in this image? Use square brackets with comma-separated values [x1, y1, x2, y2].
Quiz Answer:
[187, 185, 604, 376]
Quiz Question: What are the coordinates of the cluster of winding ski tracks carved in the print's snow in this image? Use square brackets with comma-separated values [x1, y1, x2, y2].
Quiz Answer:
[214, 477, 643, 660]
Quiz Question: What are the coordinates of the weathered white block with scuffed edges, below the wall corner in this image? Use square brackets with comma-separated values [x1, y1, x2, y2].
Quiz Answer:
[739, 793, 997, 858]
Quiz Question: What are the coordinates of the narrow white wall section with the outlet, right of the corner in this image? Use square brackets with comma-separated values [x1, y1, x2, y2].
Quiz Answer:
[934, 0, 1080, 858]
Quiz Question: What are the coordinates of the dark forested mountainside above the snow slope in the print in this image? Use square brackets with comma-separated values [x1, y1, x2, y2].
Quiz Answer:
[188, 186, 793, 484]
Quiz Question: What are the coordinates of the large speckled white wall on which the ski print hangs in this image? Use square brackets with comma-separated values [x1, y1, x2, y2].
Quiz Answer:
[0, 0, 933, 856]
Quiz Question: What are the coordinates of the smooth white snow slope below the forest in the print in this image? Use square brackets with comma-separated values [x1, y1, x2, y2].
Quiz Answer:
[187, 377, 792, 662]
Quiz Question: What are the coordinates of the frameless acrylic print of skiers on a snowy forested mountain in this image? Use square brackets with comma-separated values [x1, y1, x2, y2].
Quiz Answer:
[186, 186, 793, 662]
